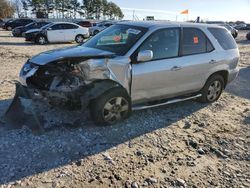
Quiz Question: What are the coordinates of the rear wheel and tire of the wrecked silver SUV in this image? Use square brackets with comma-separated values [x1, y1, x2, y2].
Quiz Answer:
[198, 74, 225, 103]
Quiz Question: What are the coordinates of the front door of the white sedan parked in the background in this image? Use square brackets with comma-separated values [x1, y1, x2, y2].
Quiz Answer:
[47, 24, 65, 42]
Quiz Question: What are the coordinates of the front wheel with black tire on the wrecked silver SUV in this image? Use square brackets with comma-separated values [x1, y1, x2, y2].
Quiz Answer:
[90, 88, 131, 126]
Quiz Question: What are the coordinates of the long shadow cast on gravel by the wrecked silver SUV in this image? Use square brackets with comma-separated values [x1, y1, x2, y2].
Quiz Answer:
[0, 97, 206, 185]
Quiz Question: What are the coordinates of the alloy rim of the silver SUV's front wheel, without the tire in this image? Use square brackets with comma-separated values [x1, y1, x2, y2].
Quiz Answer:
[103, 97, 129, 124]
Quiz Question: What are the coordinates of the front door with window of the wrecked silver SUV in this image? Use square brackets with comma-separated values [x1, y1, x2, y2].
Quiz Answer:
[131, 28, 182, 102]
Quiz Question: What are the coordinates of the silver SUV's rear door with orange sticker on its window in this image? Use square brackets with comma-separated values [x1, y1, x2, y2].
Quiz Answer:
[178, 27, 218, 93]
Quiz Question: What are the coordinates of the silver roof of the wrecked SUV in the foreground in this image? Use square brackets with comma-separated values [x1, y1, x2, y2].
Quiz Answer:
[118, 21, 224, 28]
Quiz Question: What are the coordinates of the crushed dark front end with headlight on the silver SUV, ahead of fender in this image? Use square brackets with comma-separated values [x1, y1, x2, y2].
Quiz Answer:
[16, 60, 92, 106]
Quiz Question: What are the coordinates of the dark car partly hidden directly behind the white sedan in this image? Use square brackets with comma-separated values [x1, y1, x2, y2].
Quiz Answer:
[12, 22, 50, 37]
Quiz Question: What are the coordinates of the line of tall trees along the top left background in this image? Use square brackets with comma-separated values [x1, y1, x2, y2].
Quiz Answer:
[0, 0, 124, 19]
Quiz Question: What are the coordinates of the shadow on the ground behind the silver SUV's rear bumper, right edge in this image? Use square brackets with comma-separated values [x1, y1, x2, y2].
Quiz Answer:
[226, 66, 250, 99]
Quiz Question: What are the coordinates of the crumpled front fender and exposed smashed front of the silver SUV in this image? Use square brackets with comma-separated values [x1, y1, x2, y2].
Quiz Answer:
[17, 57, 131, 108]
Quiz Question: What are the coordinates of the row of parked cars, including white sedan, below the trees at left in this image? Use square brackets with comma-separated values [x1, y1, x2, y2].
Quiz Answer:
[2, 18, 115, 45]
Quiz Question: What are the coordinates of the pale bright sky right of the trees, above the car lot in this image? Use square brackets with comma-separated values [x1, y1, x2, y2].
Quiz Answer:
[112, 0, 250, 23]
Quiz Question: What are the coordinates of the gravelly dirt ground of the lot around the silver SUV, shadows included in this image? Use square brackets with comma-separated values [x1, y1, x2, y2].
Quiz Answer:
[0, 30, 250, 188]
